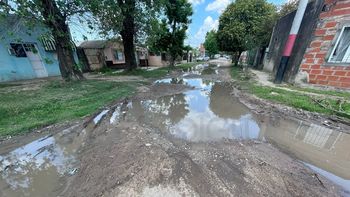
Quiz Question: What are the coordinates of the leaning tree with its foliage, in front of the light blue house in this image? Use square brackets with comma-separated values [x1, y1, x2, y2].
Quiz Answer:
[0, 0, 86, 81]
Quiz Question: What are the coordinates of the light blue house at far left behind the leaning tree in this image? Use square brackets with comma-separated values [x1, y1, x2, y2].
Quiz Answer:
[0, 15, 61, 82]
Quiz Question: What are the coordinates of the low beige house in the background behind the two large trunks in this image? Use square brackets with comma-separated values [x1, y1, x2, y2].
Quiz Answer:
[78, 39, 148, 70]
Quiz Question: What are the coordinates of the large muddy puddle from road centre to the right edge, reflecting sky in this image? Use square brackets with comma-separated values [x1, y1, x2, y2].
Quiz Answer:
[128, 78, 350, 193]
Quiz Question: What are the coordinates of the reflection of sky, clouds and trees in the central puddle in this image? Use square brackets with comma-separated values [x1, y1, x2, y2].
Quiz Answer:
[129, 78, 254, 141]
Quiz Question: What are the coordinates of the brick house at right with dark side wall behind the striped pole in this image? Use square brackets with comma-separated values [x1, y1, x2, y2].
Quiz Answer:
[264, 0, 350, 88]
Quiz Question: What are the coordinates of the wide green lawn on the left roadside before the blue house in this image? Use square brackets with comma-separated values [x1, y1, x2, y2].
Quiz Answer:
[0, 80, 136, 136]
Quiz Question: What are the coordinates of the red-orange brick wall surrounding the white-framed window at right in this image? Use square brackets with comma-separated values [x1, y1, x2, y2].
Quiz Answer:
[300, 0, 350, 88]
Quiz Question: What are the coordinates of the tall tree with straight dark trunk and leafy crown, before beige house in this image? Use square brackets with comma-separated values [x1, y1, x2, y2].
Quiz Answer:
[87, 0, 163, 70]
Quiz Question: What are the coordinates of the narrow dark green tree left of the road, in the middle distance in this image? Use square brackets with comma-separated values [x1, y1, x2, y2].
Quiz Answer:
[148, 0, 193, 67]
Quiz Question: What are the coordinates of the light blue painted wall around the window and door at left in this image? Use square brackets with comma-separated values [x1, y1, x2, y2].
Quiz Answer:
[0, 17, 60, 82]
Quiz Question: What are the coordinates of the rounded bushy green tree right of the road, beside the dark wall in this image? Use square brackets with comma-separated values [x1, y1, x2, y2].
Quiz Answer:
[217, 0, 275, 65]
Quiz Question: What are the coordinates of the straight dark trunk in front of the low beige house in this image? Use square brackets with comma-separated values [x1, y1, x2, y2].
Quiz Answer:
[118, 0, 137, 71]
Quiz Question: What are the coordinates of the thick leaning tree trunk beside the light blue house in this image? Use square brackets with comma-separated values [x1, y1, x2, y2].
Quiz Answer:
[41, 0, 84, 81]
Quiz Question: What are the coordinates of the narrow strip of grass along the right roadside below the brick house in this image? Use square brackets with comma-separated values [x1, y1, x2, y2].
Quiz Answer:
[231, 67, 350, 118]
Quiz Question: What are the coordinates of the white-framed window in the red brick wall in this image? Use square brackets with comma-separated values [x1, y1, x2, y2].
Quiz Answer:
[329, 26, 350, 63]
